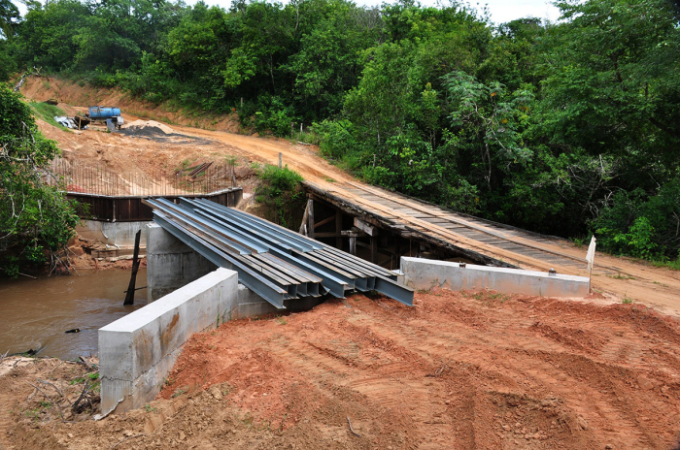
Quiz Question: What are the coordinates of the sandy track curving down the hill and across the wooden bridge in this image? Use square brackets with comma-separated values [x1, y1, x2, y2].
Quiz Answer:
[138, 122, 680, 315]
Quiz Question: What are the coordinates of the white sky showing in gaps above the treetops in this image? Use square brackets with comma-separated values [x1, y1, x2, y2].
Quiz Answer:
[12, 0, 559, 24]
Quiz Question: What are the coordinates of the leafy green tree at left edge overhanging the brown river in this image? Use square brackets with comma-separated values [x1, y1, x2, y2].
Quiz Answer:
[0, 85, 78, 276]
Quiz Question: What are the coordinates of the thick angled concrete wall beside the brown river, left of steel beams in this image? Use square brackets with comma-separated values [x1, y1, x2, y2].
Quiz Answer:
[99, 268, 238, 414]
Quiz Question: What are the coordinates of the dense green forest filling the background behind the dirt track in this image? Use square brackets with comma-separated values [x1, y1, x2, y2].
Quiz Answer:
[0, 0, 680, 264]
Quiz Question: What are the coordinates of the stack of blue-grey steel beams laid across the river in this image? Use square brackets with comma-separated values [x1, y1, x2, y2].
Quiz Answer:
[146, 198, 413, 309]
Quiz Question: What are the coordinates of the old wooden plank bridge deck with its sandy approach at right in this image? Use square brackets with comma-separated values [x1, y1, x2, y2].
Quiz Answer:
[305, 182, 680, 313]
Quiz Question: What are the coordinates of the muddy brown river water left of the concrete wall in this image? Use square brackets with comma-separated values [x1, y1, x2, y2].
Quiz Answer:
[0, 268, 146, 359]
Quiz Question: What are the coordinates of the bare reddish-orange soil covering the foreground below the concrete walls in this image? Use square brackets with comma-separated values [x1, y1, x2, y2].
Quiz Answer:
[0, 290, 680, 450]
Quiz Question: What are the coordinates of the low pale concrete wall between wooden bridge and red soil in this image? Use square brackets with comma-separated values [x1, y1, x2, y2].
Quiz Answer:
[400, 256, 590, 297]
